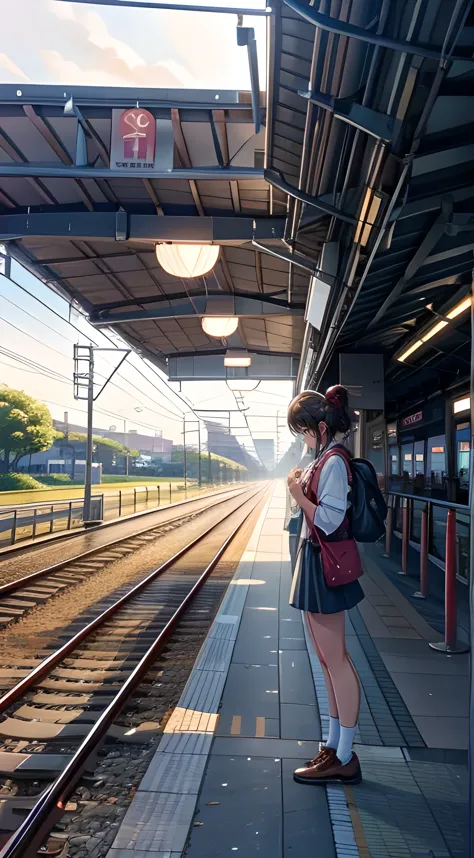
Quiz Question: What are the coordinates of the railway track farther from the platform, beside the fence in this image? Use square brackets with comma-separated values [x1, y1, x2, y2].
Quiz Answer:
[0, 489, 256, 624]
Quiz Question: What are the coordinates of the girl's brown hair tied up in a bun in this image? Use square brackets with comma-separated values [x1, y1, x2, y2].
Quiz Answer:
[287, 384, 352, 443]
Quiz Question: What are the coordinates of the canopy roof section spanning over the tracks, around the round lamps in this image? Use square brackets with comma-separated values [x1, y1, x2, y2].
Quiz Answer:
[0, 85, 315, 377]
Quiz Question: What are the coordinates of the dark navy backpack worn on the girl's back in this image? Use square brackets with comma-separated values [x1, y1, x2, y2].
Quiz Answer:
[322, 445, 387, 542]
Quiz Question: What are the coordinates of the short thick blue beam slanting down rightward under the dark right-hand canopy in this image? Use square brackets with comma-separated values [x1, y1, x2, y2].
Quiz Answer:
[298, 91, 402, 143]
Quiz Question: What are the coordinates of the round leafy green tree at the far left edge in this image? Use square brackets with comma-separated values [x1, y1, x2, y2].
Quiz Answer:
[0, 388, 58, 474]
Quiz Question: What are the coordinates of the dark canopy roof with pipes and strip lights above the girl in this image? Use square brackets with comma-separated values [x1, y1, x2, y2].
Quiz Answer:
[265, 0, 474, 406]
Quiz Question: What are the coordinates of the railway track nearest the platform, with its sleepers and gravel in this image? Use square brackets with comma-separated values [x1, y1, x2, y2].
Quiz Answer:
[0, 478, 266, 858]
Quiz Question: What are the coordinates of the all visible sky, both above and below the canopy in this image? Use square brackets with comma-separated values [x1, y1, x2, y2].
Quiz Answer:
[0, 0, 292, 462]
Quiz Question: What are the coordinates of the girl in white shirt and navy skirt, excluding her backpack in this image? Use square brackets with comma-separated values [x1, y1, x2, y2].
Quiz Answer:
[288, 385, 364, 784]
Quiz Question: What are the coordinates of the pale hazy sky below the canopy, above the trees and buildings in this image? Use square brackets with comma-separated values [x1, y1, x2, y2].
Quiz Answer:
[0, 254, 292, 455]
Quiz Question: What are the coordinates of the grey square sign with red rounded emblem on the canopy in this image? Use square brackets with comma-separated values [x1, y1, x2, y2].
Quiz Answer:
[110, 107, 174, 173]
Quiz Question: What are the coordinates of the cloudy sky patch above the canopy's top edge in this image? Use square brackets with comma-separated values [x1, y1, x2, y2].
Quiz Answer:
[0, 0, 265, 89]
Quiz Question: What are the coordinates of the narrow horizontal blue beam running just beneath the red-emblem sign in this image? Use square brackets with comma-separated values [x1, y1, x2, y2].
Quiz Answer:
[0, 166, 265, 182]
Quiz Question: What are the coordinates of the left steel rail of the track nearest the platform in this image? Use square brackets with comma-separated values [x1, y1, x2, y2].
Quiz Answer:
[0, 486, 267, 712]
